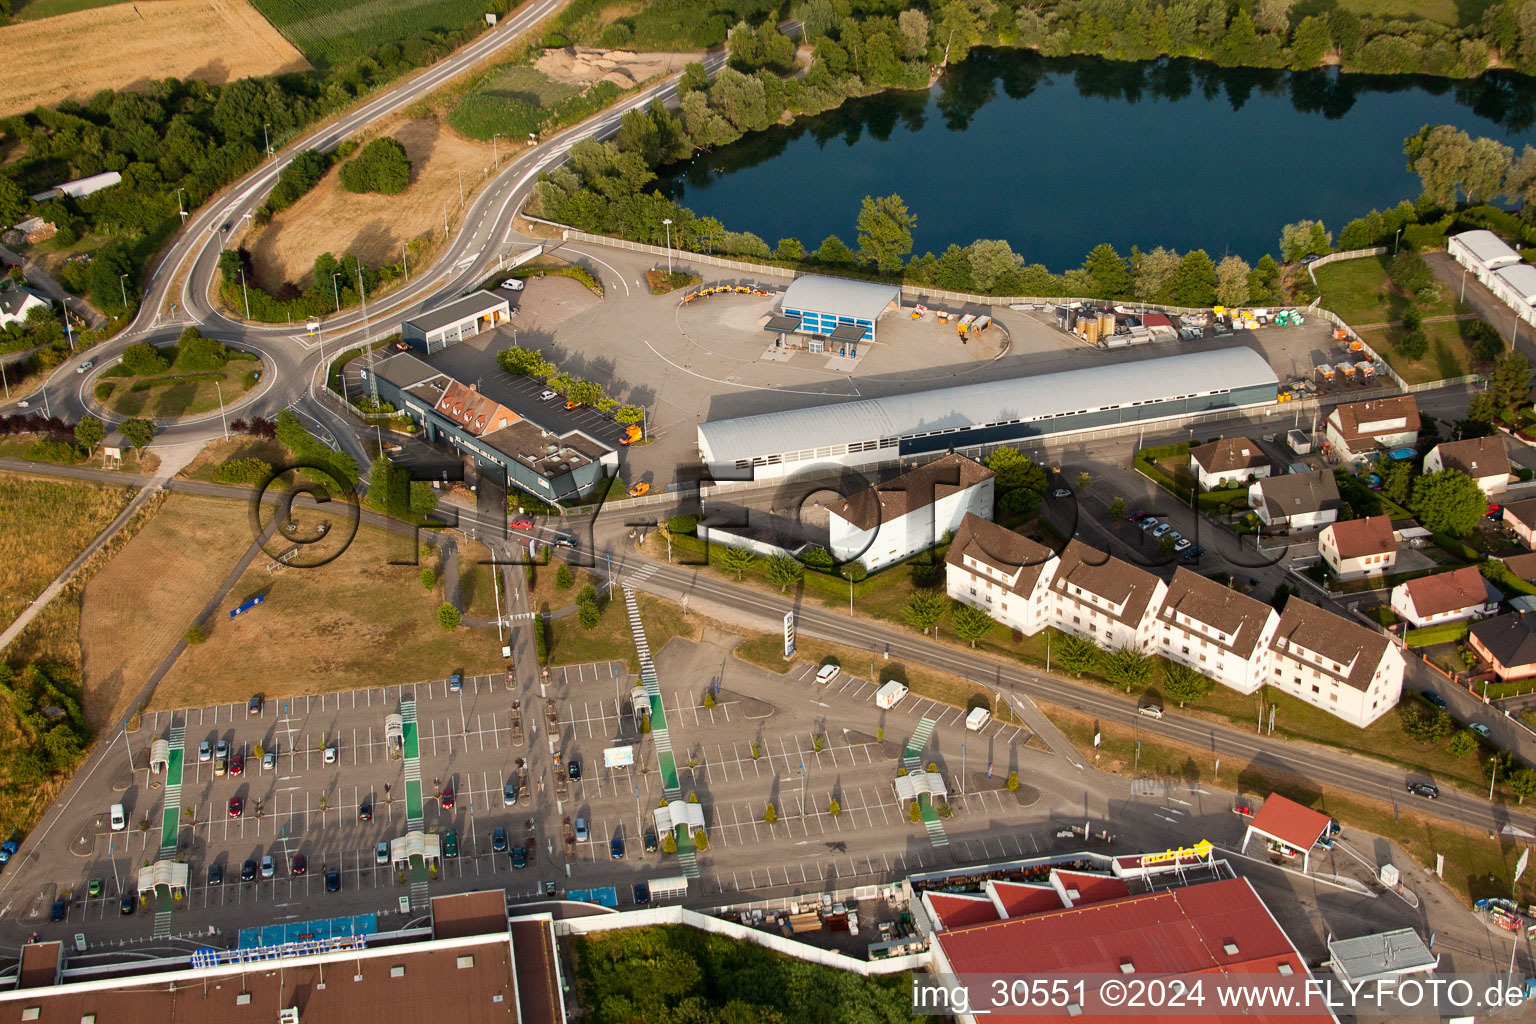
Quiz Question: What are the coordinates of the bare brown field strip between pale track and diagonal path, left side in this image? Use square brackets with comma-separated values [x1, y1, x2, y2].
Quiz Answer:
[80, 494, 250, 729]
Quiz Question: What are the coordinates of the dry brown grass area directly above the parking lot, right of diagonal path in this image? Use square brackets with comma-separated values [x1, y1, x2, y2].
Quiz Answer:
[152, 515, 504, 708]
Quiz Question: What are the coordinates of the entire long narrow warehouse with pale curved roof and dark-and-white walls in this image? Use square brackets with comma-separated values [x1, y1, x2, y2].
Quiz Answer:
[699, 347, 1279, 481]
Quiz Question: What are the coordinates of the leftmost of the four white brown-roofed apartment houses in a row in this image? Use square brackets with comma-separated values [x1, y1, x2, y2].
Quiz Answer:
[945, 514, 1057, 636]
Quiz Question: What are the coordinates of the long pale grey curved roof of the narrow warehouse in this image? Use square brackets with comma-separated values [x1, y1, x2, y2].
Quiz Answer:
[699, 347, 1279, 464]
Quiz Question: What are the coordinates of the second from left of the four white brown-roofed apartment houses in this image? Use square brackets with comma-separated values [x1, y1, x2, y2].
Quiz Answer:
[1049, 540, 1167, 649]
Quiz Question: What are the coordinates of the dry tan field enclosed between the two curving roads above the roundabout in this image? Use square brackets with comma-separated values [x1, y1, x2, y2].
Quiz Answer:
[247, 117, 491, 292]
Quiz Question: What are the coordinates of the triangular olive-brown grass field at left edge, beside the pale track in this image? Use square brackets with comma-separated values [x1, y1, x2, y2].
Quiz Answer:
[0, 473, 134, 635]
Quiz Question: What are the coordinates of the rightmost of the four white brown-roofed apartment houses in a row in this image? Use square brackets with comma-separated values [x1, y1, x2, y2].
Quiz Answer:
[1269, 597, 1404, 728]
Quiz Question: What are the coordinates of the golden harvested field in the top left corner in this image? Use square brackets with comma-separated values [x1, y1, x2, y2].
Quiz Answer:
[0, 0, 309, 115]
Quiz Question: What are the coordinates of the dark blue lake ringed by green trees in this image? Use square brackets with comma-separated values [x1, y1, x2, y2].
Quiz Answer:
[660, 51, 1536, 272]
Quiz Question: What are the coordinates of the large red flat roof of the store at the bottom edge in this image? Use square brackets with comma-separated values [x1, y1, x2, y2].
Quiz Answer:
[932, 872, 1338, 1024]
